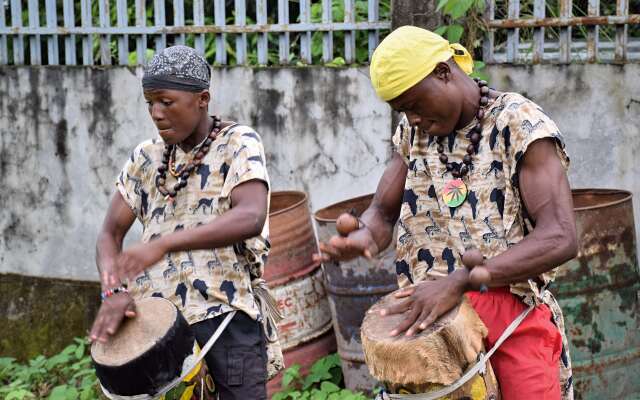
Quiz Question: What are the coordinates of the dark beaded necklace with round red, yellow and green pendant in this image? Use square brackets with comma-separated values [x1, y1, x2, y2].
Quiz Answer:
[437, 78, 489, 208]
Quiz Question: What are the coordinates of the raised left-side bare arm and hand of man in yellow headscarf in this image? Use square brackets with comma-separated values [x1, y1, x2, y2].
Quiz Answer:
[314, 153, 408, 261]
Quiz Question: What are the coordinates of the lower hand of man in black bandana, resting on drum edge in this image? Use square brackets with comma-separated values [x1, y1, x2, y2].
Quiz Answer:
[89, 293, 136, 343]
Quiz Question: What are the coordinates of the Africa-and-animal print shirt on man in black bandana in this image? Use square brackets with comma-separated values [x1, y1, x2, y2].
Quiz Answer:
[116, 125, 269, 324]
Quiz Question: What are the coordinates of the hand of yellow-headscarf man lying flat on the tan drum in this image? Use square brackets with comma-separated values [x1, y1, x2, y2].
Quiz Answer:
[380, 269, 469, 336]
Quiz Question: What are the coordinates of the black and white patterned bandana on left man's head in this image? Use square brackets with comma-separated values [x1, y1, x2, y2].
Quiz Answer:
[142, 46, 211, 92]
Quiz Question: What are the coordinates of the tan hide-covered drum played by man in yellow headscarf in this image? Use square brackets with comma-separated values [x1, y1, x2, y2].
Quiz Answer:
[361, 292, 500, 400]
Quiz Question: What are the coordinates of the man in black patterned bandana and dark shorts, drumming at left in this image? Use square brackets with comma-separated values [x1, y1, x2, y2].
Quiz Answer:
[90, 46, 282, 400]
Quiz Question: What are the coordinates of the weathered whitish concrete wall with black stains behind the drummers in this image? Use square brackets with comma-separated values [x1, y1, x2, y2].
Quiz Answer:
[0, 65, 640, 280]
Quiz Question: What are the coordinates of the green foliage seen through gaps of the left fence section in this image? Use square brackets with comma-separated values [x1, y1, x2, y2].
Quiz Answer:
[9, 0, 391, 66]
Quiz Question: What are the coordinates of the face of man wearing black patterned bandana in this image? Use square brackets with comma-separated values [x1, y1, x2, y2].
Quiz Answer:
[144, 89, 208, 144]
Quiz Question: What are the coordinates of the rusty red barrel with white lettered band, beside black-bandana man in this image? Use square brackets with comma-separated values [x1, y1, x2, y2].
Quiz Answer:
[264, 191, 336, 395]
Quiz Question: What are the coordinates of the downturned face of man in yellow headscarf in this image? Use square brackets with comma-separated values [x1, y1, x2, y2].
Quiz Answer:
[389, 64, 462, 136]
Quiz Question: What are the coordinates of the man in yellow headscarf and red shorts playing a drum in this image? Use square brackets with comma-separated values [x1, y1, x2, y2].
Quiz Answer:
[317, 26, 577, 400]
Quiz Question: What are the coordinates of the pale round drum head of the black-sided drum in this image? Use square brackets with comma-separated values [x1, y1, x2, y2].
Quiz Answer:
[91, 297, 178, 366]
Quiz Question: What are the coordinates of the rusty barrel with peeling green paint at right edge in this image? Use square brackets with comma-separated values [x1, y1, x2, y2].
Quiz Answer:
[552, 189, 640, 399]
